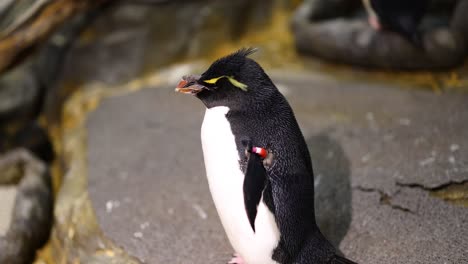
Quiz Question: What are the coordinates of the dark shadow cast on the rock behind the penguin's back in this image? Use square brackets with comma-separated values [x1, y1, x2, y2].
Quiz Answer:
[307, 133, 351, 247]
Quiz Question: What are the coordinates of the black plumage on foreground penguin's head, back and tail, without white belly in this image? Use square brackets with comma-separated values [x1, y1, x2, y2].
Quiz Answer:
[178, 49, 354, 264]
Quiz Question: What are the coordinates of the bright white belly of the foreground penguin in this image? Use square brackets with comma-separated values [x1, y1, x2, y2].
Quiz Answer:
[201, 106, 280, 264]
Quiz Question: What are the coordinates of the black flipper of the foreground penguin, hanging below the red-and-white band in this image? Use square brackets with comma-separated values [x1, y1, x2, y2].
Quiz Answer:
[243, 141, 267, 232]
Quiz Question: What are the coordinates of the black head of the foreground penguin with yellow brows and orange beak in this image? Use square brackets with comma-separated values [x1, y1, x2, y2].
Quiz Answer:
[175, 48, 276, 109]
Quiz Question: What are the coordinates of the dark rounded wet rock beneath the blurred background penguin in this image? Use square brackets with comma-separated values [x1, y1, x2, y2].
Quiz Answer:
[293, 0, 468, 70]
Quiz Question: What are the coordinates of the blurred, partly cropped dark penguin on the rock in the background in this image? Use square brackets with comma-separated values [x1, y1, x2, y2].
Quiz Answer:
[362, 0, 429, 47]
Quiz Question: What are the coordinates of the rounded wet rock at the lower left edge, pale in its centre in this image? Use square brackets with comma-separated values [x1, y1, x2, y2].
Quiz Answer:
[0, 150, 53, 264]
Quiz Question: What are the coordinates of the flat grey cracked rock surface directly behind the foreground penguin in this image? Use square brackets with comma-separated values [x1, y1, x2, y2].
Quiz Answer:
[87, 73, 468, 263]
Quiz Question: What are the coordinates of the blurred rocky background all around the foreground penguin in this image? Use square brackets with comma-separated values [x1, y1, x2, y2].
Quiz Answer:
[0, 0, 468, 264]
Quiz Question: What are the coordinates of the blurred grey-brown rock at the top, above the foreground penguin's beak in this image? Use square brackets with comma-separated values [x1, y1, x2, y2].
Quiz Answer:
[60, 0, 275, 84]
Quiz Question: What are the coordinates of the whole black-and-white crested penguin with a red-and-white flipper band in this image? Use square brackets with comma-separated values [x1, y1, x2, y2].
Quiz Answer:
[175, 48, 355, 264]
